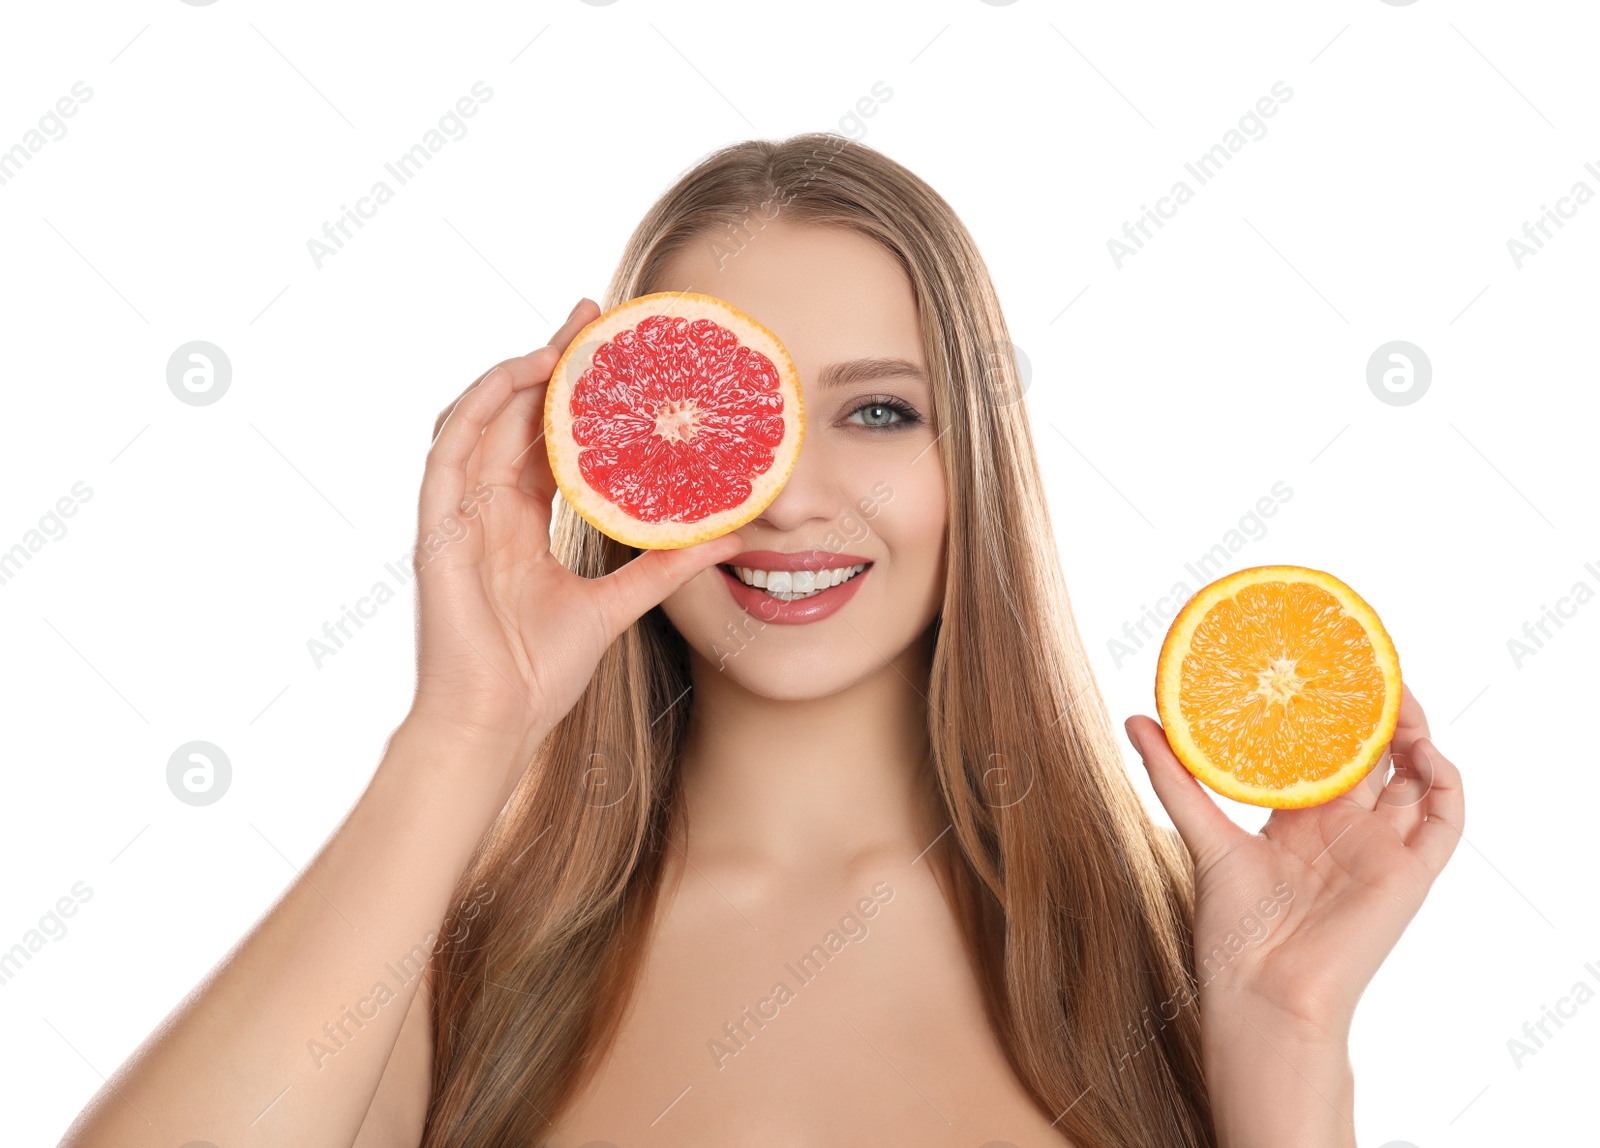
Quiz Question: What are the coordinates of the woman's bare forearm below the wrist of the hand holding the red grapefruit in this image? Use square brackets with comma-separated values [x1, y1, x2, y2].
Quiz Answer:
[62, 718, 544, 1148]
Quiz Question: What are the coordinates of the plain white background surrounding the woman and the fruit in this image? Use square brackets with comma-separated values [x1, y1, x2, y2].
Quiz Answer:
[0, 0, 1600, 1148]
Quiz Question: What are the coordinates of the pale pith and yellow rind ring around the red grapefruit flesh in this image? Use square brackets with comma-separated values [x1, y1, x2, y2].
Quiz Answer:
[544, 291, 805, 550]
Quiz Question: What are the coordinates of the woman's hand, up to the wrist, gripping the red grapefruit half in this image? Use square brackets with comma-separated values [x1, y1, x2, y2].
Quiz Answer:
[408, 299, 742, 783]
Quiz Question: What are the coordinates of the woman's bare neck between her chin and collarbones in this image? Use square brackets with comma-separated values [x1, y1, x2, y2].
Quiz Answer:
[680, 643, 942, 871]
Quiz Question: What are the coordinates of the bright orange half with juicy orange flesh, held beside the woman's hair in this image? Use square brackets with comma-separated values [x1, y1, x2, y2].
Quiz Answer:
[1155, 566, 1400, 809]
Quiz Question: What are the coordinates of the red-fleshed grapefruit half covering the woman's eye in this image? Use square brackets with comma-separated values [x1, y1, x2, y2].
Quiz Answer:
[544, 291, 805, 550]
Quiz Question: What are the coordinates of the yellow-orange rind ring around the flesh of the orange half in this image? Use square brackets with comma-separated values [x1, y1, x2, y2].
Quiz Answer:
[1155, 566, 1400, 809]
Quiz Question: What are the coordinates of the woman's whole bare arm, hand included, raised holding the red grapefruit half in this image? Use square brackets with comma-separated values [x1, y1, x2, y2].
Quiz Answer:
[61, 299, 744, 1148]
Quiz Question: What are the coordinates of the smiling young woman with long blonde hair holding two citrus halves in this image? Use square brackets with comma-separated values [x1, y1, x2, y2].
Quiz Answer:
[66, 134, 1462, 1148]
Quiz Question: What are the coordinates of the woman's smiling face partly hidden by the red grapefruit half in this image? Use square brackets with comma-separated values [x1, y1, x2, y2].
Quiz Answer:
[653, 216, 946, 699]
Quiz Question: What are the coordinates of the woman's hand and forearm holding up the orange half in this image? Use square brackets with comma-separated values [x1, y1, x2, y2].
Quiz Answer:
[1126, 688, 1464, 1148]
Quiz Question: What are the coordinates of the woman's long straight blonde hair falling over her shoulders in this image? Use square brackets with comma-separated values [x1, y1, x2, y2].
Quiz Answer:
[422, 133, 1214, 1148]
